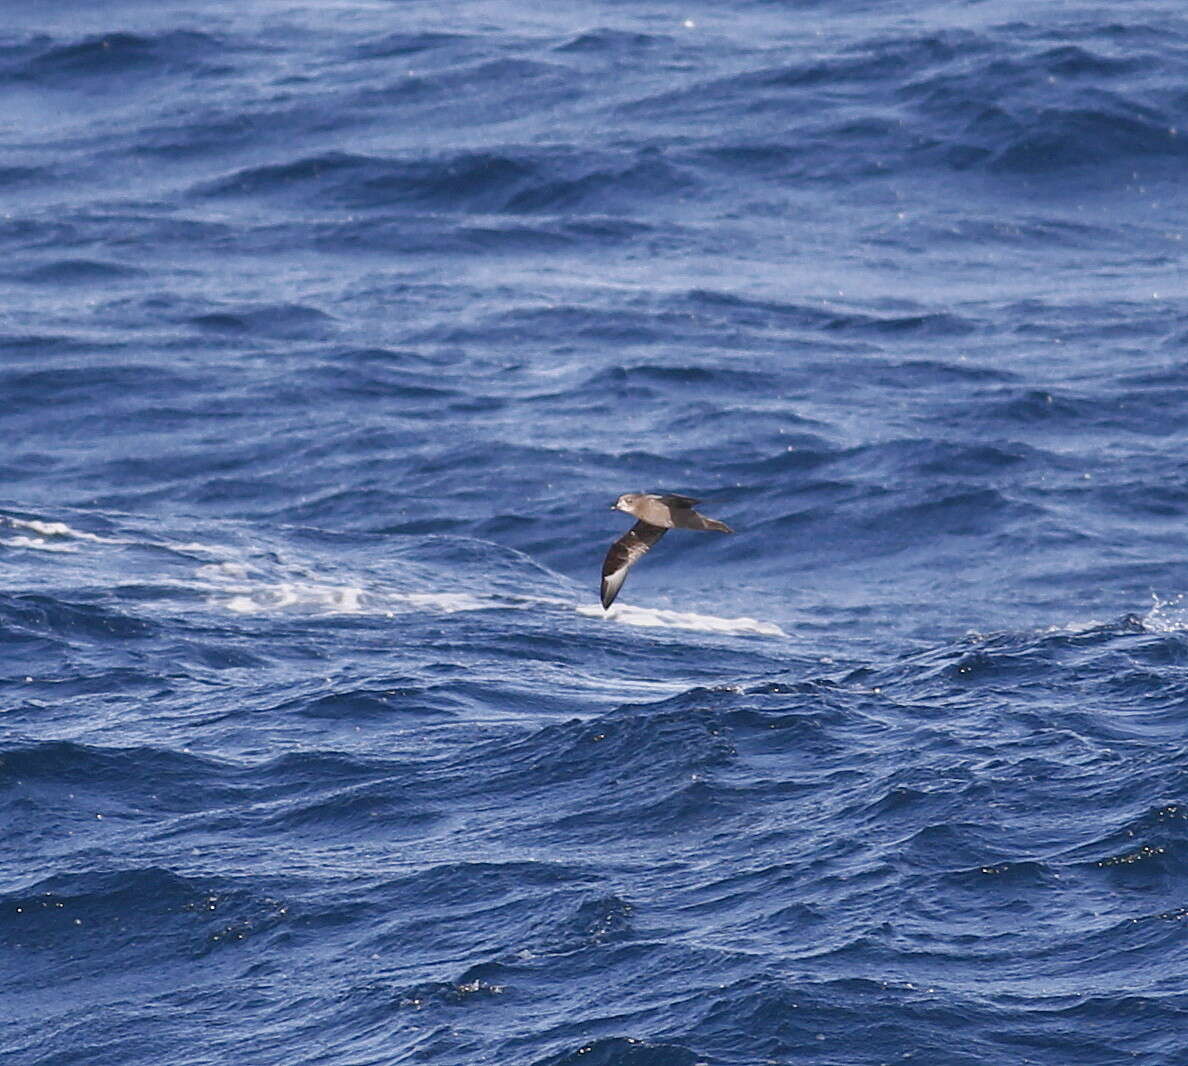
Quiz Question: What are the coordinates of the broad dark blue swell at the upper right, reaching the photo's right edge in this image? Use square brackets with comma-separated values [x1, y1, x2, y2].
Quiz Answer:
[620, 23, 1186, 181]
